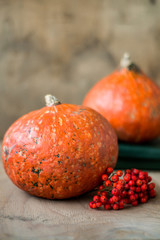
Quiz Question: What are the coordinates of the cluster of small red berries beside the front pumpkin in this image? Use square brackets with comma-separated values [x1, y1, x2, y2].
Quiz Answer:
[89, 167, 156, 210]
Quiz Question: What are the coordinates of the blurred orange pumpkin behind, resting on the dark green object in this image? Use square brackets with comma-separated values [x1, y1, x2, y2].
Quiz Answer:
[83, 54, 160, 142]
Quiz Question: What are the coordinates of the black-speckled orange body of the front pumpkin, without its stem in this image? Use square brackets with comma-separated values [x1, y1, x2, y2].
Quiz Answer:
[2, 104, 118, 199]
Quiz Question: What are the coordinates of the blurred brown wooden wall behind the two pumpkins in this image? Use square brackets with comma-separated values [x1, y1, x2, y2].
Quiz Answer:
[0, 0, 160, 138]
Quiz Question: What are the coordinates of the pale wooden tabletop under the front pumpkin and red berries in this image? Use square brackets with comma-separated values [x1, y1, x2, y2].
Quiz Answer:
[0, 142, 160, 240]
